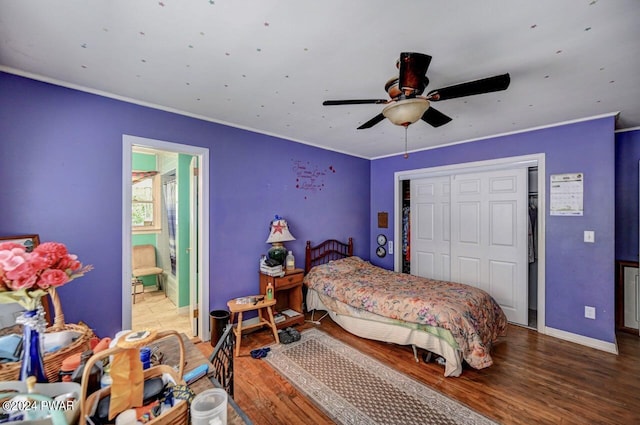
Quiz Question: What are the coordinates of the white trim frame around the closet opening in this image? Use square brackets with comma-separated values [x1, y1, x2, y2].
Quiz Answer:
[393, 153, 547, 334]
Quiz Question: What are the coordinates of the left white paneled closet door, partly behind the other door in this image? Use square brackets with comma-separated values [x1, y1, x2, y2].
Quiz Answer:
[410, 176, 451, 280]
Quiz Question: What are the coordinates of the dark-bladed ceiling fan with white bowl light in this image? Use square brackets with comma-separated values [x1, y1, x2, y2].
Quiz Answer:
[322, 52, 511, 130]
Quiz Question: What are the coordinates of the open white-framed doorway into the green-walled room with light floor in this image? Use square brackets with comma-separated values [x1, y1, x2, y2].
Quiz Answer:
[122, 135, 209, 341]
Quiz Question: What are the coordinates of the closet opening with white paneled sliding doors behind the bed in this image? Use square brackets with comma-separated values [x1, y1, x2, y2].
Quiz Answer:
[401, 167, 537, 328]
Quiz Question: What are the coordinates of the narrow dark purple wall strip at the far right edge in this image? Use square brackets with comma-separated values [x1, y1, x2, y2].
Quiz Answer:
[616, 130, 640, 261]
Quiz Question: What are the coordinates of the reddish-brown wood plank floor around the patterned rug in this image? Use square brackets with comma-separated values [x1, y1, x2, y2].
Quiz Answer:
[199, 317, 640, 425]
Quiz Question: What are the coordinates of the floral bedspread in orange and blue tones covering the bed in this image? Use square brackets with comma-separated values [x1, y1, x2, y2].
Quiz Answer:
[305, 257, 507, 369]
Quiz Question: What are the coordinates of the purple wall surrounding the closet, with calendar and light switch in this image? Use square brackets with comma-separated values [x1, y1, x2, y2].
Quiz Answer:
[370, 117, 615, 342]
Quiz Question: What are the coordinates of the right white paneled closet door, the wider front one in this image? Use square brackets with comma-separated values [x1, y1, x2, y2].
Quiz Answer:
[451, 168, 528, 326]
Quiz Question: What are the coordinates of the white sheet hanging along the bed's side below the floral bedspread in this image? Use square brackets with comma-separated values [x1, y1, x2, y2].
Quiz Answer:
[306, 289, 462, 377]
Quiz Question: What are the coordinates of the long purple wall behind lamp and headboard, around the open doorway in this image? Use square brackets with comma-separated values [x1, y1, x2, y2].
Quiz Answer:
[0, 72, 370, 336]
